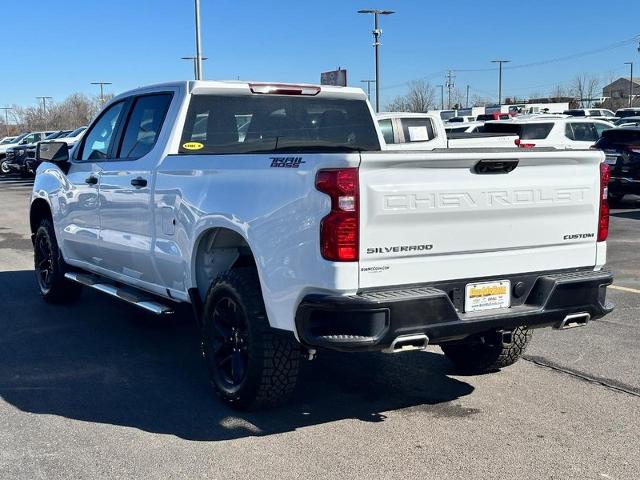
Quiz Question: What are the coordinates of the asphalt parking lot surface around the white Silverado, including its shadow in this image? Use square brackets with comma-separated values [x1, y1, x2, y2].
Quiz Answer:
[0, 177, 640, 479]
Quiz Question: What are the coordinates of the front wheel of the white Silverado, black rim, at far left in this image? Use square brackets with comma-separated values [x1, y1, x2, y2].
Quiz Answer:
[33, 218, 82, 304]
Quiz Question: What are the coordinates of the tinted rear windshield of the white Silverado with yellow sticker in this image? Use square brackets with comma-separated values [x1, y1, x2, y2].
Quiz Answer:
[179, 95, 380, 154]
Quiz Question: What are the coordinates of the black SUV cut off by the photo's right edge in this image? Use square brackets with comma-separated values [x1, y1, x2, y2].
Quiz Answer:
[595, 127, 640, 202]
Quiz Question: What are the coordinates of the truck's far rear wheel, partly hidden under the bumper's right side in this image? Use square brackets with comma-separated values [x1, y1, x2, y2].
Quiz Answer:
[440, 327, 531, 373]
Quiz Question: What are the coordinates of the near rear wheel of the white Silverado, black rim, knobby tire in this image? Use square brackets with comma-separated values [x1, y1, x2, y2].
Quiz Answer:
[202, 268, 301, 410]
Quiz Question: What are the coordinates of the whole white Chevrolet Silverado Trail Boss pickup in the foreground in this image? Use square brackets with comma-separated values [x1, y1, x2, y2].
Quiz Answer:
[30, 81, 613, 409]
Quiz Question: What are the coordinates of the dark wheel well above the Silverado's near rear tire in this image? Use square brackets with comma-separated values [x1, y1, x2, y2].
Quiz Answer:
[194, 228, 255, 301]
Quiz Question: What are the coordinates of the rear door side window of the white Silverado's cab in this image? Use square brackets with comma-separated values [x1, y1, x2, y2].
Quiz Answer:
[117, 93, 171, 159]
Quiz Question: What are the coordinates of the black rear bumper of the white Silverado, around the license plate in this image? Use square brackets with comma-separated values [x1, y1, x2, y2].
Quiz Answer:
[296, 270, 613, 351]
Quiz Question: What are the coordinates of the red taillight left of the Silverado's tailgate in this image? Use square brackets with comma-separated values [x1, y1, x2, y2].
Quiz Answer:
[316, 168, 360, 262]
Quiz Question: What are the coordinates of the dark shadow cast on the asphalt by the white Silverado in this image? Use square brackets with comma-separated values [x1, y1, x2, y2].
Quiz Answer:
[0, 270, 474, 441]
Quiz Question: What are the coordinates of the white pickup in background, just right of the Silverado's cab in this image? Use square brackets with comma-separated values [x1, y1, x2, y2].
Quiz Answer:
[377, 112, 518, 150]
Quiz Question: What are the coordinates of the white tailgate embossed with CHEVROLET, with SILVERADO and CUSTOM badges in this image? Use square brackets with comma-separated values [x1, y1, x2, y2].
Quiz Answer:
[360, 150, 603, 288]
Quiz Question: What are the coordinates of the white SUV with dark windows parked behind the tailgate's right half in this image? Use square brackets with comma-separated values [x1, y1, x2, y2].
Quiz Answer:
[484, 116, 614, 150]
